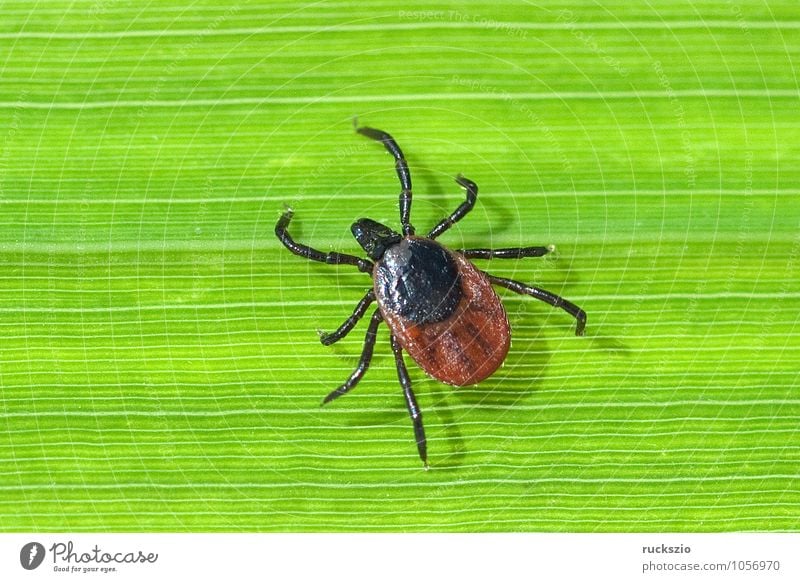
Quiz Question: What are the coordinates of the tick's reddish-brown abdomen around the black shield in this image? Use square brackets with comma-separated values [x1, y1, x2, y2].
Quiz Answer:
[376, 251, 511, 386]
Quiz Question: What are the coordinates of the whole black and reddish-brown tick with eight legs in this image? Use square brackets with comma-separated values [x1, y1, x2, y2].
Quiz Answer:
[275, 127, 586, 469]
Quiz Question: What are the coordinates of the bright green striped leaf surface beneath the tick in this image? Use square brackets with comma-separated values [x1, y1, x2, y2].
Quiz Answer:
[0, 0, 800, 531]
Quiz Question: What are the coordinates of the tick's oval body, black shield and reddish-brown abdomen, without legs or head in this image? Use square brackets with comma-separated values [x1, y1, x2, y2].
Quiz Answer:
[373, 237, 510, 386]
